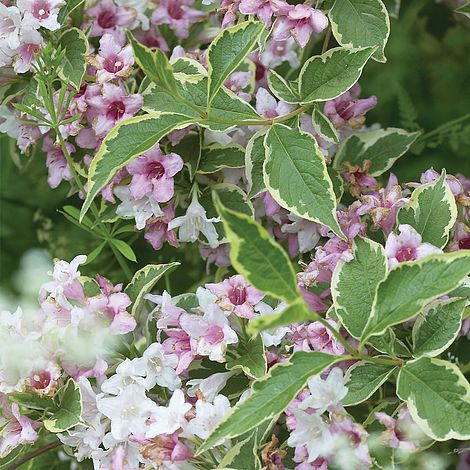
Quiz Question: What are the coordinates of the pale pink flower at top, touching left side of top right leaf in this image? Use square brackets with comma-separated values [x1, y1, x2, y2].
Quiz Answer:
[273, 4, 328, 47]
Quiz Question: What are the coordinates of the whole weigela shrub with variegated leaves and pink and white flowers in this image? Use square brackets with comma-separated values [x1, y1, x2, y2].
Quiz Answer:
[0, 0, 470, 470]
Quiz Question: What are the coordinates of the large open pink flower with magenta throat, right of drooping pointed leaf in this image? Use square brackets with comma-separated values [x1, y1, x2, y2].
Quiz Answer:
[126, 144, 183, 203]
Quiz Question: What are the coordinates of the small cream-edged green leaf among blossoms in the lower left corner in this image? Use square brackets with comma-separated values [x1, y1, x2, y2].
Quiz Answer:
[44, 379, 82, 433]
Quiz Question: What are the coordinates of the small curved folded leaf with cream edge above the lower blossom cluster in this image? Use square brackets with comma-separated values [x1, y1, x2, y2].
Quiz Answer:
[124, 262, 180, 315]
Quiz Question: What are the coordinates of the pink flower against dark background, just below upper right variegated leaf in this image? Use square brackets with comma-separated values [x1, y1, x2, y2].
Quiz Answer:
[323, 83, 377, 129]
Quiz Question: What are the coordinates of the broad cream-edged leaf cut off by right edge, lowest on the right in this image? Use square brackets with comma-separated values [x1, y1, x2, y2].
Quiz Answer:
[397, 357, 470, 441]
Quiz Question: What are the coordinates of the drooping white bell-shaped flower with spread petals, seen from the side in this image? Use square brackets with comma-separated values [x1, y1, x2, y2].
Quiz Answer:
[168, 191, 220, 248]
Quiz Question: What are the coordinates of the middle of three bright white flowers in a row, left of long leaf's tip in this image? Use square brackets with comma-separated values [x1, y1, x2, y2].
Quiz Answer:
[145, 389, 192, 438]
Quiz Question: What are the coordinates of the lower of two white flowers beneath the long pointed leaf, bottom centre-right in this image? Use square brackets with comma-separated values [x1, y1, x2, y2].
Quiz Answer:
[287, 410, 333, 462]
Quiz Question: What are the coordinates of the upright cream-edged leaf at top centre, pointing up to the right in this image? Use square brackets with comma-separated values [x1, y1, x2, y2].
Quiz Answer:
[207, 21, 264, 107]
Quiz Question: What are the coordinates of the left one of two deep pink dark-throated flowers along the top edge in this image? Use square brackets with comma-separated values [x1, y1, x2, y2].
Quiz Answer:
[86, 0, 136, 38]
